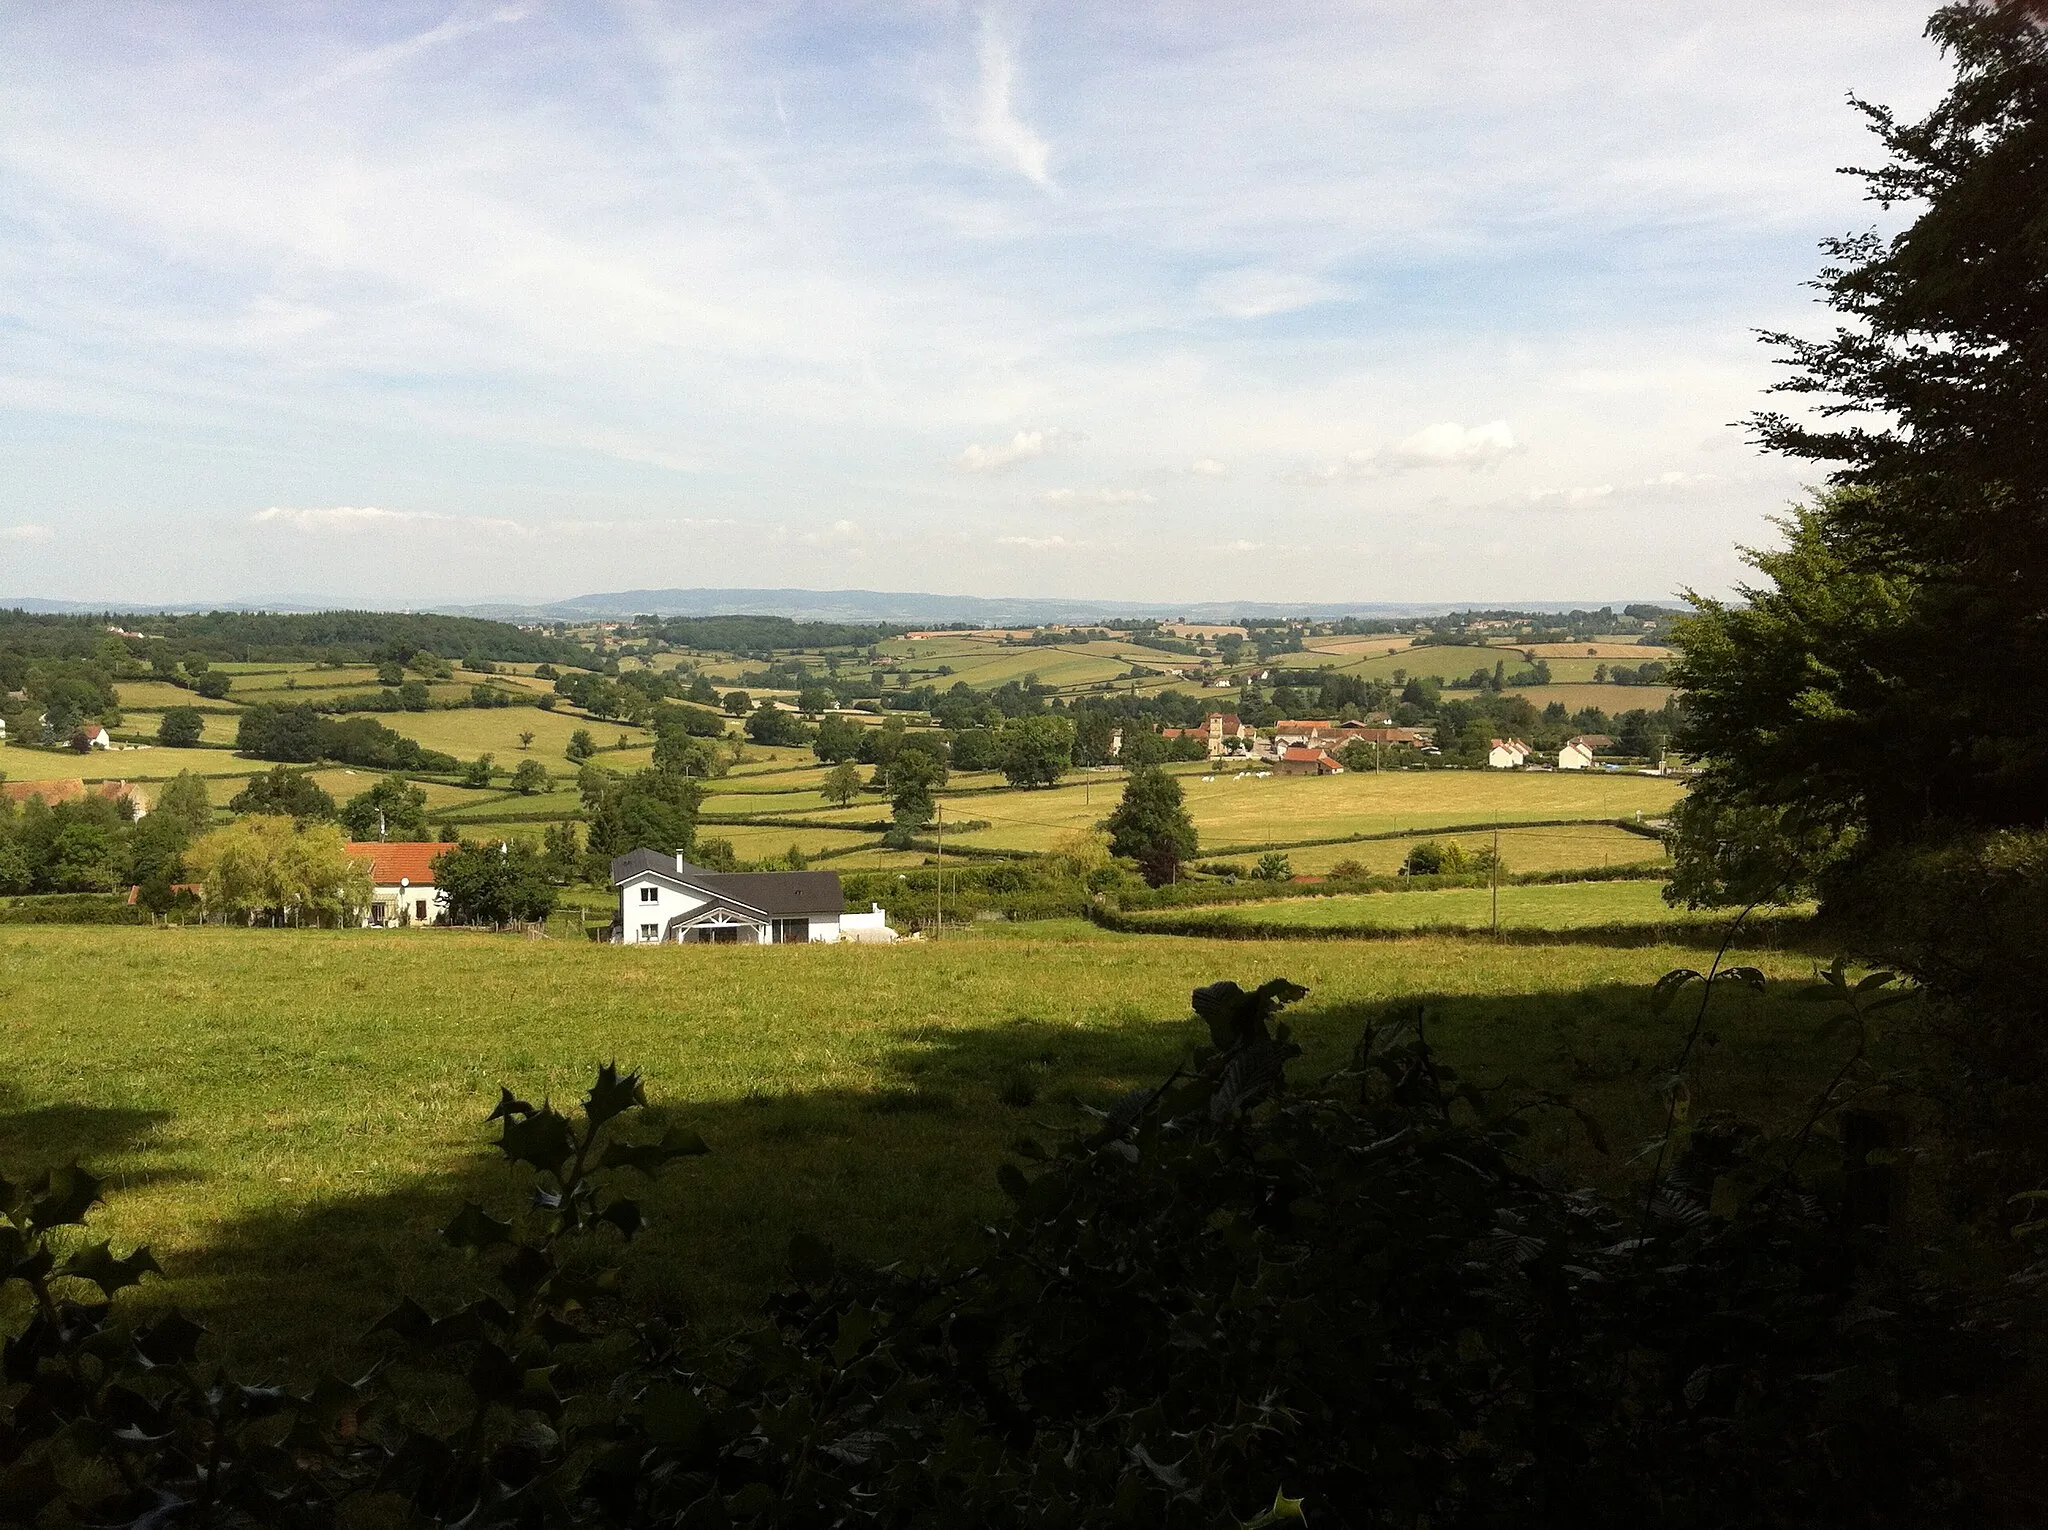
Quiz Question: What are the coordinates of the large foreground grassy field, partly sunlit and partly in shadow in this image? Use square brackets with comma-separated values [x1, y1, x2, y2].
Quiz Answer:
[0, 921, 1821, 1370]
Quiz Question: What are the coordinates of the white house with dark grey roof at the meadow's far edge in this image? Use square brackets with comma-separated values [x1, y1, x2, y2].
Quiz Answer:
[612, 850, 895, 946]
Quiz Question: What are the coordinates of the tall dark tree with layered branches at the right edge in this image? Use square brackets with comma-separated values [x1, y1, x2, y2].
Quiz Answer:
[1703, 4, 2048, 844]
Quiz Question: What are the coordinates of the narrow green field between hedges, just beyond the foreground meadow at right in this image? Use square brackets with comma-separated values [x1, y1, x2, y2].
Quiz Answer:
[1133, 883, 1726, 930]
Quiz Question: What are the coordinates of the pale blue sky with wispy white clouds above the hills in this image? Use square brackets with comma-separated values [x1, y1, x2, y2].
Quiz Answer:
[0, 0, 1946, 604]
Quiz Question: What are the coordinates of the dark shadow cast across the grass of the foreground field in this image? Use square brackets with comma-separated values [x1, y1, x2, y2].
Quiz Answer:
[0, 987, 1829, 1374]
